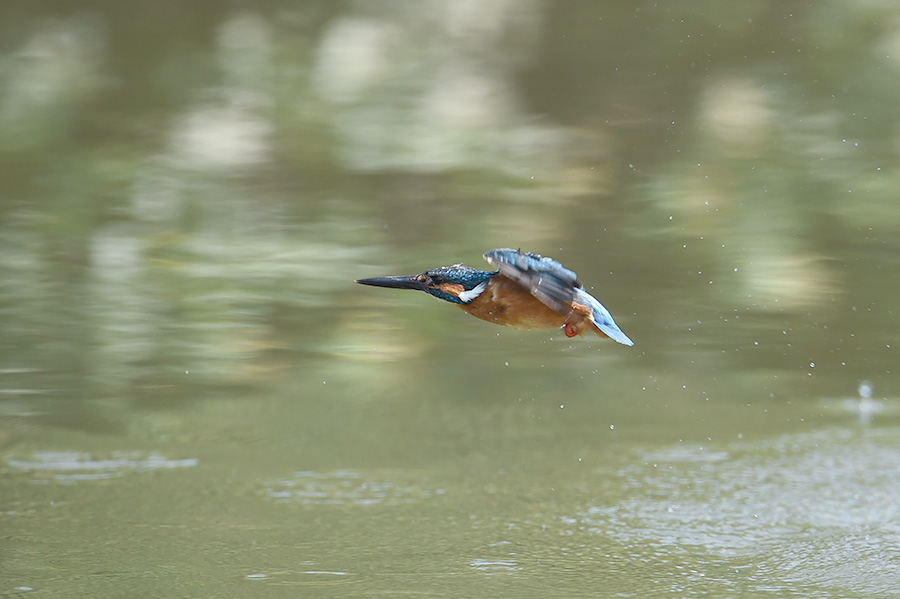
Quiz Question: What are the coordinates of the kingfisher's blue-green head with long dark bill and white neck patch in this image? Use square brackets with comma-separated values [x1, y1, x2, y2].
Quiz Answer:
[356, 264, 497, 305]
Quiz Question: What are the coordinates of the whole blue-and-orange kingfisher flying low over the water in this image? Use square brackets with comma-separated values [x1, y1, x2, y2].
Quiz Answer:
[356, 248, 634, 345]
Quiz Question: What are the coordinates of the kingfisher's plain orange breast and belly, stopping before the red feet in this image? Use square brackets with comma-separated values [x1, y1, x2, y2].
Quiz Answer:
[460, 275, 568, 329]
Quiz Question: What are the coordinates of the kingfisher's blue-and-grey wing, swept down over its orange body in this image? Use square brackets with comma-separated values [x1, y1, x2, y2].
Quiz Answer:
[484, 248, 582, 314]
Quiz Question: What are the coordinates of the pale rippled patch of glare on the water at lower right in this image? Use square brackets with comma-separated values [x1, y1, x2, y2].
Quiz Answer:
[579, 429, 900, 593]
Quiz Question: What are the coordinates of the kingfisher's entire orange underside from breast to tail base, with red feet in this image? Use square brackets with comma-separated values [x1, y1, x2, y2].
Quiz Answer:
[460, 275, 606, 337]
